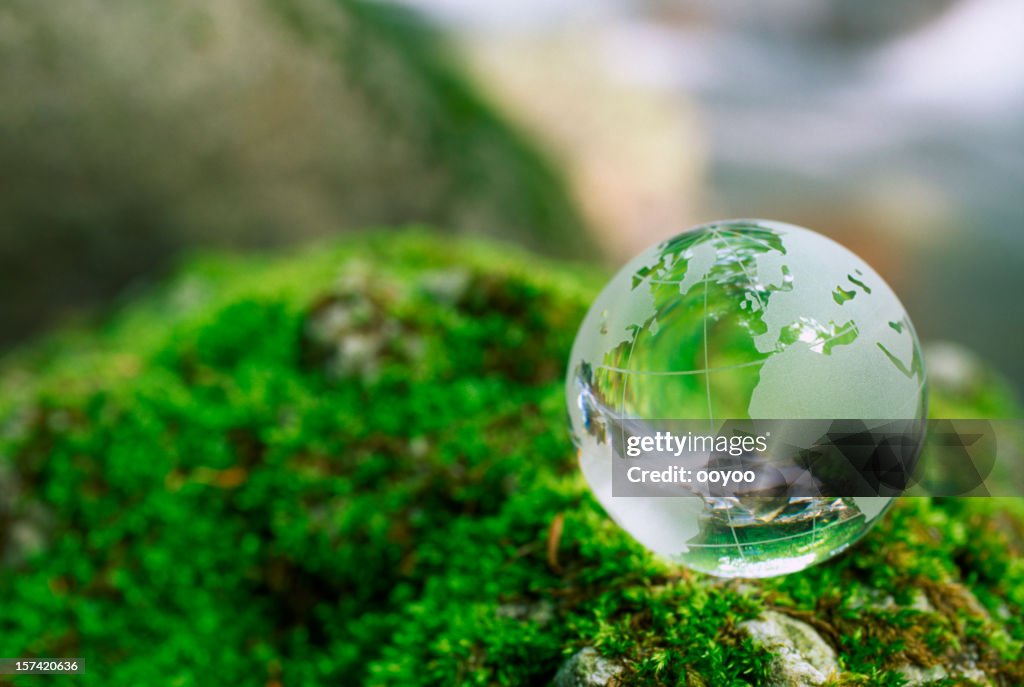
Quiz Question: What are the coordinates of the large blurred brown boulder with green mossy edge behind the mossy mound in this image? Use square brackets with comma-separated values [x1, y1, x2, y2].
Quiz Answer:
[0, 0, 588, 346]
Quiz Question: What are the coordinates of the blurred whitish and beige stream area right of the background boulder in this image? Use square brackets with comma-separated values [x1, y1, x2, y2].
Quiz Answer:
[406, 0, 1024, 395]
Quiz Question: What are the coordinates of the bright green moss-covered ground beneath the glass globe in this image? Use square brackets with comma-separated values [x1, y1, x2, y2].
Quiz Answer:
[0, 231, 1024, 686]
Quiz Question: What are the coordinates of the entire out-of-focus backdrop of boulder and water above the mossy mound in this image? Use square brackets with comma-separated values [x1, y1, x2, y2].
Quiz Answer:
[0, 0, 1024, 389]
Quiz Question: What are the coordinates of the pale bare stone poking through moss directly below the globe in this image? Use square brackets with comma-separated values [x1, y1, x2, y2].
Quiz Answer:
[739, 610, 839, 687]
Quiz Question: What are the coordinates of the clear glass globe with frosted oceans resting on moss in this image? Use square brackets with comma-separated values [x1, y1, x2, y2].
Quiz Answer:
[566, 220, 926, 577]
